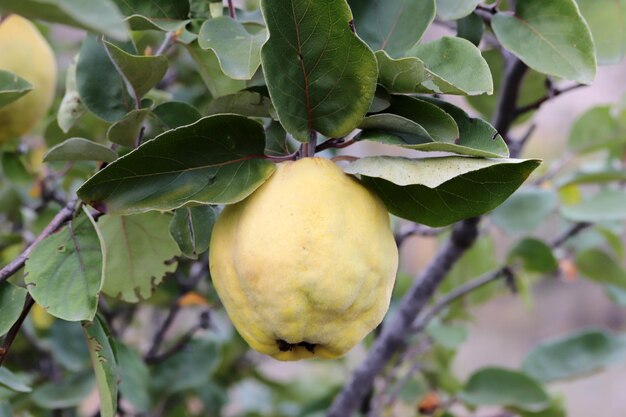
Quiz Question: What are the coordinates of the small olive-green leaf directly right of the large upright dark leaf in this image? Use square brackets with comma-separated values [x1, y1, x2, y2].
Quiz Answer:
[376, 51, 428, 94]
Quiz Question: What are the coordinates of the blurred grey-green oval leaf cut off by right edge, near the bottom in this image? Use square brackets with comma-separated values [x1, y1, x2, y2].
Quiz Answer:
[523, 328, 626, 382]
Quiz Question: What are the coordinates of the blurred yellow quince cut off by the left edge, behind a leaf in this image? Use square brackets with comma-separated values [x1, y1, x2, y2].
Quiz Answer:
[0, 14, 57, 145]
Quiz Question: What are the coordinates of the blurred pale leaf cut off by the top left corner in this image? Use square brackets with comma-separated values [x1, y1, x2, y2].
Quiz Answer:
[0, 0, 128, 40]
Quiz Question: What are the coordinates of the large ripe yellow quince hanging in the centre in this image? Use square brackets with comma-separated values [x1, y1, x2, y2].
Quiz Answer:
[209, 158, 398, 360]
